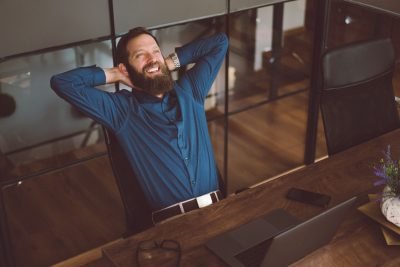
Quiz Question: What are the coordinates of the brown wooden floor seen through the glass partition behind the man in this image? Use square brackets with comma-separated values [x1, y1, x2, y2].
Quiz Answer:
[3, 27, 399, 267]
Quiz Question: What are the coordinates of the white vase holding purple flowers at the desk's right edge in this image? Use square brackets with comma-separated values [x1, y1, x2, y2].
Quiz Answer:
[381, 186, 400, 227]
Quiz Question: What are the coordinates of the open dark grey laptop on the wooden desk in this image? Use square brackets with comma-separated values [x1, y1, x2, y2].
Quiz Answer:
[206, 197, 357, 267]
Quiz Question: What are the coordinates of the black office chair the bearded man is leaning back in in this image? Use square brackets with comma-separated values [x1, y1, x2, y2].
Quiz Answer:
[103, 128, 225, 237]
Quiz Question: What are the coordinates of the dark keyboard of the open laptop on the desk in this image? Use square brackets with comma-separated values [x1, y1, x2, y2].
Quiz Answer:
[235, 238, 272, 267]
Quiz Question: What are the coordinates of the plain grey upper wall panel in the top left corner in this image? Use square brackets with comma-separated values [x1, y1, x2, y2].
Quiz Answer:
[0, 0, 111, 58]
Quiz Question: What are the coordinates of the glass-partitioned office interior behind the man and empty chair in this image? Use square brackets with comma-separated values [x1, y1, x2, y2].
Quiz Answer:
[0, 0, 400, 266]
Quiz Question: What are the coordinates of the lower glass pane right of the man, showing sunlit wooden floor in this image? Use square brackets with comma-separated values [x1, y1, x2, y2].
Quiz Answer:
[228, 92, 308, 195]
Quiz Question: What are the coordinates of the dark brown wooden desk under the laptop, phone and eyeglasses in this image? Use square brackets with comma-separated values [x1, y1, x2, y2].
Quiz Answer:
[83, 129, 400, 267]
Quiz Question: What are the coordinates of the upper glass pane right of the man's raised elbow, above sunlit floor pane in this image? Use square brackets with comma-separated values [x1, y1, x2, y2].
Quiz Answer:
[229, 1, 312, 111]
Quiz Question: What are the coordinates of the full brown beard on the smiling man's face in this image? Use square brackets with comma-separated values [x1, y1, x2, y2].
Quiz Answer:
[127, 63, 174, 95]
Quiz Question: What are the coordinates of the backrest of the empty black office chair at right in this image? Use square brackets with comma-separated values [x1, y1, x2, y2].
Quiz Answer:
[321, 39, 399, 155]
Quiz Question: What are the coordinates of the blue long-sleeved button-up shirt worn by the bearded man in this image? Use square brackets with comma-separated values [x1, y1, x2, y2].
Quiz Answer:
[51, 34, 228, 210]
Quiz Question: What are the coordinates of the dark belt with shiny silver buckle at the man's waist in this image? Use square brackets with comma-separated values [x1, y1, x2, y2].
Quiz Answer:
[152, 190, 222, 224]
